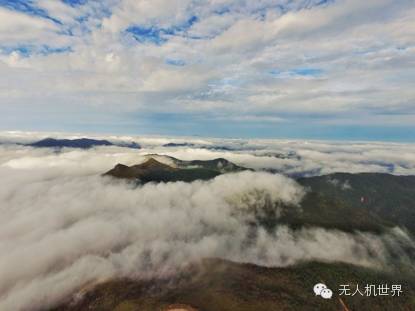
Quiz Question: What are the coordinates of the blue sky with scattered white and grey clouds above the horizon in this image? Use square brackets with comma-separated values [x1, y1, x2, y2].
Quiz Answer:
[0, 0, 415, 141]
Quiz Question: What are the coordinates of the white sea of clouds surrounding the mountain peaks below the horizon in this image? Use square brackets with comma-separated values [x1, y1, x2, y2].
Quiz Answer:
[0, 133, 415, 310]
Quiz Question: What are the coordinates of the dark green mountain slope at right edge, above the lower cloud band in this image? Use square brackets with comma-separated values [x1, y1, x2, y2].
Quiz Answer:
[298, 173, 415, 233]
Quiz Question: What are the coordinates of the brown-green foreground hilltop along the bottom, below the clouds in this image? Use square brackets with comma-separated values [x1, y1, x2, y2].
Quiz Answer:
[51, 259, 415, 311]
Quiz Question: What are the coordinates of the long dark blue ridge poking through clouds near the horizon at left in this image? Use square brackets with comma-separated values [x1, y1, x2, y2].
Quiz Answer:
[26, 138, 141, 149]
